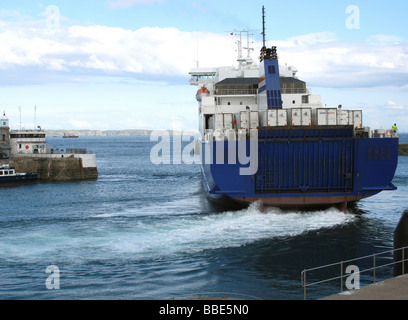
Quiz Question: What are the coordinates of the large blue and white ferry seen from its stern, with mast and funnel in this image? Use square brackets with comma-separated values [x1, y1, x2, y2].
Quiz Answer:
[190, 9, 398, 210]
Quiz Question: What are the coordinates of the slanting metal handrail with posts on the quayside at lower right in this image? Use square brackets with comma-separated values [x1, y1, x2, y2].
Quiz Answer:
[301, 247, 408, 300]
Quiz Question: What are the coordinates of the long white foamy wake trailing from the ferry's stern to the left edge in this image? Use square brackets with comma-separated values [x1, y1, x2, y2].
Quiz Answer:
[2, 200, 354, 261]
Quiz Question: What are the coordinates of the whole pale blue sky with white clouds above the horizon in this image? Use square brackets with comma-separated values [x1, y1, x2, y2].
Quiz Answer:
[0, 0, 408, 132]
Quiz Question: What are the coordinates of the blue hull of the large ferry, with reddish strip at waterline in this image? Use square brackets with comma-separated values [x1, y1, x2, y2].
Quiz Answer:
[201, 126, 398, 208]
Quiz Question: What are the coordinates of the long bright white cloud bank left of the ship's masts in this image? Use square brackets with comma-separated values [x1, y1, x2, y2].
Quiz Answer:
[0, 22, 234, 84]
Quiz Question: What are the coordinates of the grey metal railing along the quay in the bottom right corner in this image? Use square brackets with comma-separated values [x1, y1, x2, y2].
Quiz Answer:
[301, 247, 408, 300]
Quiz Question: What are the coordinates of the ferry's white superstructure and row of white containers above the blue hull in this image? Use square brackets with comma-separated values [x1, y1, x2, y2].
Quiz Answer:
[190, 30, 363, 142]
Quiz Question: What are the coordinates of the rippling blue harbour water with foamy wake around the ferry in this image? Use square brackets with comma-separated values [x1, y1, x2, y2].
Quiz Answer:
[0, 137, 408, 299]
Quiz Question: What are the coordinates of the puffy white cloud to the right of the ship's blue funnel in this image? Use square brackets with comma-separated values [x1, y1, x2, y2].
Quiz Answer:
[279, 33, 408, 88]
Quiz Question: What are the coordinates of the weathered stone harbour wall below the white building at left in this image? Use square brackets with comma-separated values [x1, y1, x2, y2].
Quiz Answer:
[1, 155, 98, 182]
